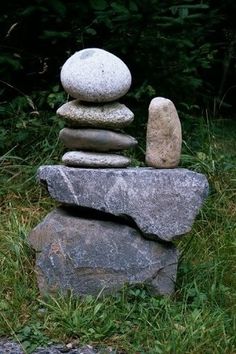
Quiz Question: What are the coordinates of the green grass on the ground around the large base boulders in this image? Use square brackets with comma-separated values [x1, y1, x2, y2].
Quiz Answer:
[0, 120, 236, 354]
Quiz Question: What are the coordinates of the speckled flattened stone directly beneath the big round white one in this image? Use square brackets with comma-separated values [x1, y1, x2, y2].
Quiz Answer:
[57, 100, 134, 129]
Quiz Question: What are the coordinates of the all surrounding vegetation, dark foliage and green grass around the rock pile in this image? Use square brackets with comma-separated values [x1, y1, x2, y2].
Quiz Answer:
[0, 0, 236, 354]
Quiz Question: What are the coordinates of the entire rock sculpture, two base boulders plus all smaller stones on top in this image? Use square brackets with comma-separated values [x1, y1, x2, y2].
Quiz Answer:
[29, 48, 208, 295]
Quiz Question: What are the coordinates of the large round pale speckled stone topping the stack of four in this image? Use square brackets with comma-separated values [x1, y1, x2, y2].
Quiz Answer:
[61, 48, 131, 102]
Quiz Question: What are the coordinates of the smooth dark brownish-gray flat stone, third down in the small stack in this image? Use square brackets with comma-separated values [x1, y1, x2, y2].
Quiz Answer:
[59, 128, 137, 151]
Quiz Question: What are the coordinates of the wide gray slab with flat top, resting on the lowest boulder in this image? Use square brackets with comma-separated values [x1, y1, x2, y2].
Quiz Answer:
[38, 165, 208, 241]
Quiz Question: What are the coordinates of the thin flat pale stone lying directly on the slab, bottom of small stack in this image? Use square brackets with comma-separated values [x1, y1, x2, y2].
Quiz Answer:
[62, 151, 131, 167]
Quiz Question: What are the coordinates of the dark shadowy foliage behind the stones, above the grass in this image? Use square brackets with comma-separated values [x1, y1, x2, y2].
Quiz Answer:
[0, 0, 236, 153]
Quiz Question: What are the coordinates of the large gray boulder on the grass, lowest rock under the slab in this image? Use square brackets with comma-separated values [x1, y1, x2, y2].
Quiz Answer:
[29, 208, 178, 295]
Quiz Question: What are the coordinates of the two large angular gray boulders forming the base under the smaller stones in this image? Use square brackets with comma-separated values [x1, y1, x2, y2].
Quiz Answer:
[30, 165, 208, 295]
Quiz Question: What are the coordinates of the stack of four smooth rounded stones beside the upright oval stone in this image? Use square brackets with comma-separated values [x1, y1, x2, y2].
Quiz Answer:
[57, 48, 137, 168]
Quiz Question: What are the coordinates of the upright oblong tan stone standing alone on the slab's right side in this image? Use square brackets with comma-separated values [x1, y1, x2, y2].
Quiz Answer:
[146, 97, 182, 168]
